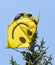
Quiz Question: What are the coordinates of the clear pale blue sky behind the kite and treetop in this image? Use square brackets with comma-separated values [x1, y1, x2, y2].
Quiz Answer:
[0, 0, 55, 65]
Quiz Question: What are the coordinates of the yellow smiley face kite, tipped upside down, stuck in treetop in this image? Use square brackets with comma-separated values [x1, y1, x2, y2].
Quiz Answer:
[6, 13, 39, 48]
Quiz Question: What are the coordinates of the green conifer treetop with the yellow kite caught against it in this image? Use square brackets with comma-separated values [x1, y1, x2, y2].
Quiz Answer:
[11, 31, 52, 65]
